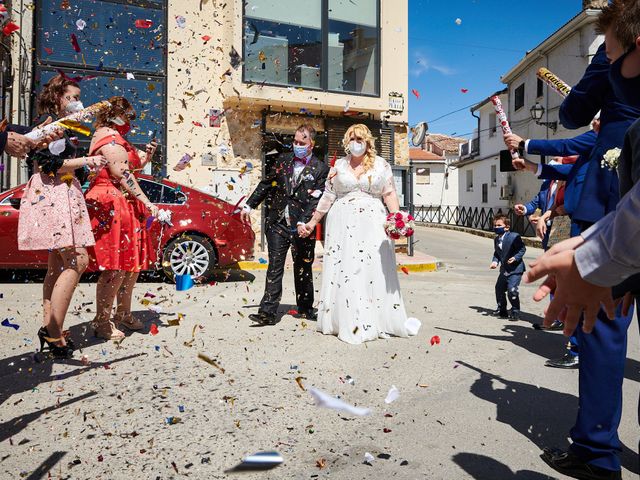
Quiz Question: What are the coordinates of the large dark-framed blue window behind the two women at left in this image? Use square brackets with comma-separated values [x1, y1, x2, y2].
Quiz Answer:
[34, 0, 167, 167]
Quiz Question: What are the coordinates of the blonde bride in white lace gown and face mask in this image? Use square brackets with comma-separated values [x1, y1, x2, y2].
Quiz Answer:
[305, 124, 420, 344]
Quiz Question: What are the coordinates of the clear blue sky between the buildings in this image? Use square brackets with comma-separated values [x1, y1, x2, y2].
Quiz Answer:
[410, 0, 582, 138]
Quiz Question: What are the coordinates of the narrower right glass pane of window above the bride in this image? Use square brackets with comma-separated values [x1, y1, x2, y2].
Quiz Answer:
[327, 0, 379, 95]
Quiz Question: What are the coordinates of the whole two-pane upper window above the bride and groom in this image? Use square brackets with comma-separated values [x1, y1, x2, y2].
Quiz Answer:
[243, 0, 380, 96]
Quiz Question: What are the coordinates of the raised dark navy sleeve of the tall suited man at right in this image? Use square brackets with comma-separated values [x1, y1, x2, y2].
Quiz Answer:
[560, 42, 611, 130]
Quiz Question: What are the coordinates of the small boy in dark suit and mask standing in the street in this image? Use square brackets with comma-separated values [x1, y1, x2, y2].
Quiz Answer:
[489, 214, 527, 320]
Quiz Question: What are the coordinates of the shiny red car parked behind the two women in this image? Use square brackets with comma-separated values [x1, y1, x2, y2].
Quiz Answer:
[0, 175, 255, 280]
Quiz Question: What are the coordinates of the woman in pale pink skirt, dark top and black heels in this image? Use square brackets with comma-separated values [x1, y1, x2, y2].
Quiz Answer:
[18, 76, 105, 358]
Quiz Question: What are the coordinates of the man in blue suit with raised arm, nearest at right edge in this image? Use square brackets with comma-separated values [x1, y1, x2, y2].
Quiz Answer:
[510, 28, 640, 480]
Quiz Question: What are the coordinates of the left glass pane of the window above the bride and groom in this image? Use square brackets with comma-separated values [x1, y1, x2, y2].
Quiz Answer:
[244, 0, 322, 89]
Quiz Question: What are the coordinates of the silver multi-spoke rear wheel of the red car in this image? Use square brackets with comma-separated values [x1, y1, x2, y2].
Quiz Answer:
[162, 234, 218, 281]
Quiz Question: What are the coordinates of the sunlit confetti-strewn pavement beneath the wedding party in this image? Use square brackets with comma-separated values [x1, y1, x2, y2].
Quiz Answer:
[0, 228, 640, 480]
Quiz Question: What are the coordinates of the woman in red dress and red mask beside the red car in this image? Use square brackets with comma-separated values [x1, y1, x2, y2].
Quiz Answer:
[86, 97, 158, 340]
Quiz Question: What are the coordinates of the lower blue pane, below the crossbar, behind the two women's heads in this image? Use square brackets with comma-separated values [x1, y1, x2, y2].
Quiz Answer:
[36, 68, 165, 145]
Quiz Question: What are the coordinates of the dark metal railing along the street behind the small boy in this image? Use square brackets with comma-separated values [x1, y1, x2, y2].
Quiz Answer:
[413, 205, 536, 237]
